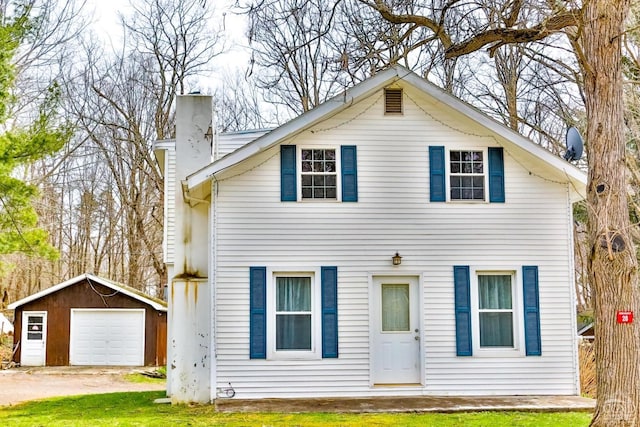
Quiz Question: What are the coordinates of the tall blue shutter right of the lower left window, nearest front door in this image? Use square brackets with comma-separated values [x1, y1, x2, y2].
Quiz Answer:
[320, 267, 338, 359]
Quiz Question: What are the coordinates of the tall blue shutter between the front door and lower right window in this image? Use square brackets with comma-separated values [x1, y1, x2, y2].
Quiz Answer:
[453, 265, 473, 356]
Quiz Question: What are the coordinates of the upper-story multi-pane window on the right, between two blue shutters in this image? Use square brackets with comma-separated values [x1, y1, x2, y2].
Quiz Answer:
[449, 150, 485, 200]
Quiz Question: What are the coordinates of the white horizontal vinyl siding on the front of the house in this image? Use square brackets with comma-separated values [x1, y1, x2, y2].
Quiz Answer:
[212, 83, 578, 398]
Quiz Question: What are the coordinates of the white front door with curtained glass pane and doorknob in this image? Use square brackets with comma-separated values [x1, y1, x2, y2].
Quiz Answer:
[371, 276, 421, 385]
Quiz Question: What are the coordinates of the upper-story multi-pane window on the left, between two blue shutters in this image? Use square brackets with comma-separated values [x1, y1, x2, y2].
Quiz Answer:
[300, 148, 338, 200]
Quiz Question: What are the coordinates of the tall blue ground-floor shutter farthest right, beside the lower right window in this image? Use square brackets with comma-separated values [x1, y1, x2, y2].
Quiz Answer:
[522, 265, 542, 356]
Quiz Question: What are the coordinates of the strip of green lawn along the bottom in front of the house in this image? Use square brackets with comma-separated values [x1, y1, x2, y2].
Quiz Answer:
[0, 391, 591, 427]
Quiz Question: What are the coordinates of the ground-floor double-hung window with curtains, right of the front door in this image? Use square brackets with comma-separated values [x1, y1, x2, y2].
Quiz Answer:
[478, 274, 514, 349]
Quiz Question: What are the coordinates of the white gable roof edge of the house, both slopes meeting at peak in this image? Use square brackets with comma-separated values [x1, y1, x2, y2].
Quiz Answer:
[186, 65, 587, 198]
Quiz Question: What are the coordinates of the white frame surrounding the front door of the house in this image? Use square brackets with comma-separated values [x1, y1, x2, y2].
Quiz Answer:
[369, 272, 425, 387]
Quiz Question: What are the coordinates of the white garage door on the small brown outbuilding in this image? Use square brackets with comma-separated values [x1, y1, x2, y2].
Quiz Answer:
[69, 309, 144, 366]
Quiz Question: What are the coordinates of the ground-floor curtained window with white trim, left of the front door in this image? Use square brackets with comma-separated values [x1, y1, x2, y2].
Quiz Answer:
[267, 272, 321, 359]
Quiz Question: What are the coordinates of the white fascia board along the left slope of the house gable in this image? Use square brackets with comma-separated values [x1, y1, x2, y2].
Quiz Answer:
[187, 68, 399, 189]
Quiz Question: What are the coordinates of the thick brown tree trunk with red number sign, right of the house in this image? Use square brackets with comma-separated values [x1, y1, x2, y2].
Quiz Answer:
[582, 0, 640, 427]
